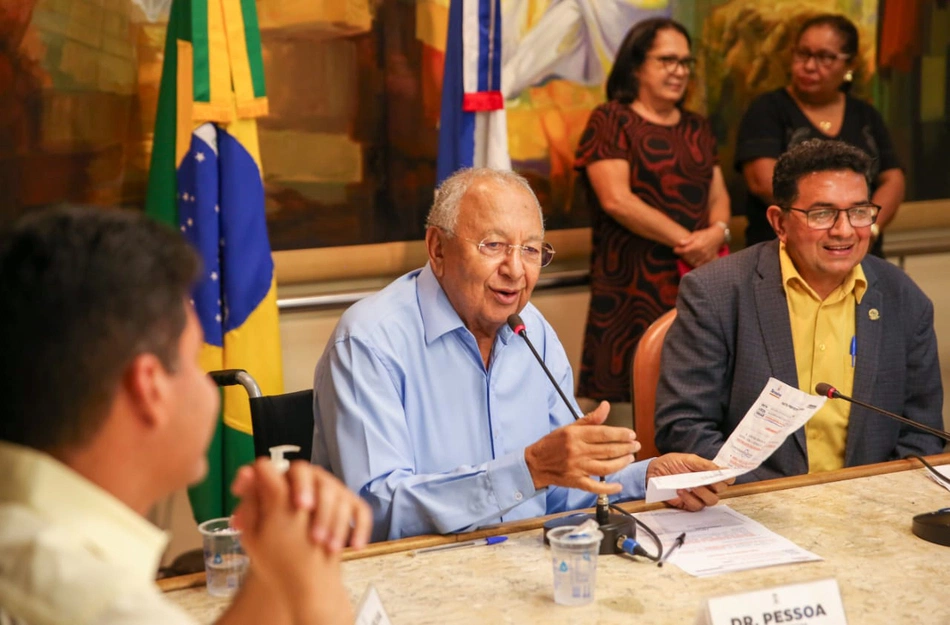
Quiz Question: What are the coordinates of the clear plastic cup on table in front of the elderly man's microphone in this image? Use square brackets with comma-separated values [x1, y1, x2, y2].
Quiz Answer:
[548, 525, 604, 605]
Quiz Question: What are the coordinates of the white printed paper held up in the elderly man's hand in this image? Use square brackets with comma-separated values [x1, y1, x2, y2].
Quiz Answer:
[646, 378, 827, 503]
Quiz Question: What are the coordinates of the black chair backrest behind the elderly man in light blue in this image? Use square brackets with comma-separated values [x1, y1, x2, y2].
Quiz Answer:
[250, 389, 313, 462]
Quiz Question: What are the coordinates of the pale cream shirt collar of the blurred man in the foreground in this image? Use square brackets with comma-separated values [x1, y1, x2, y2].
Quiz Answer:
[0, 441, 168, 583]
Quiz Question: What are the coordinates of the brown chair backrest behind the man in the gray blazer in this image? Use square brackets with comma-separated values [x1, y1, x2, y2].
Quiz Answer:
[631, 308, 676, 460]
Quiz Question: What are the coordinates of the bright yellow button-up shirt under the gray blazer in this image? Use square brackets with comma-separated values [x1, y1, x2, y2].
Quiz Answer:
[779, 245, 868, 473]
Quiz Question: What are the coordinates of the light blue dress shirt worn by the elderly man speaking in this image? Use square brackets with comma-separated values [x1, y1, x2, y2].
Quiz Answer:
[313, 265, 648, 540]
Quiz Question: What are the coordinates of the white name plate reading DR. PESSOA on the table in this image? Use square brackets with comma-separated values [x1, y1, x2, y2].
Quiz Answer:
[696, 579, 848, 625]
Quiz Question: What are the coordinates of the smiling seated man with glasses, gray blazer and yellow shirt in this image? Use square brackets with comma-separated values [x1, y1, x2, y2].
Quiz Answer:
[656, 140, 943, 482]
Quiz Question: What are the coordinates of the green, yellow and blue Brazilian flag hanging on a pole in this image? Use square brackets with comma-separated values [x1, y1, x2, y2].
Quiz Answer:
[146, 0, 283, 522]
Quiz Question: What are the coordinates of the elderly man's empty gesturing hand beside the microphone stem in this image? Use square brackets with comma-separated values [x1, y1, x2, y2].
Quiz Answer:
[524, 402, 640, 495]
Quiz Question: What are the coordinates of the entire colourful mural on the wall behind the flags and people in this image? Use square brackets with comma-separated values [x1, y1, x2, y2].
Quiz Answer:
[0, 0, 948, 250]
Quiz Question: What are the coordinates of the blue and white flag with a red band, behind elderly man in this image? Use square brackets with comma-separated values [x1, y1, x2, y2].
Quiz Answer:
[436, 0, 511, 184]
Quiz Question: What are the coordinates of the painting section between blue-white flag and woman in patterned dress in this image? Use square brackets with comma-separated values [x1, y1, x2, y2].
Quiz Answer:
[502, 0, 675, 228]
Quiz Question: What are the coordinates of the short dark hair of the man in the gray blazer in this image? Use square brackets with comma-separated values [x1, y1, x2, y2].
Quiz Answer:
[772, 139, 871, 210]
